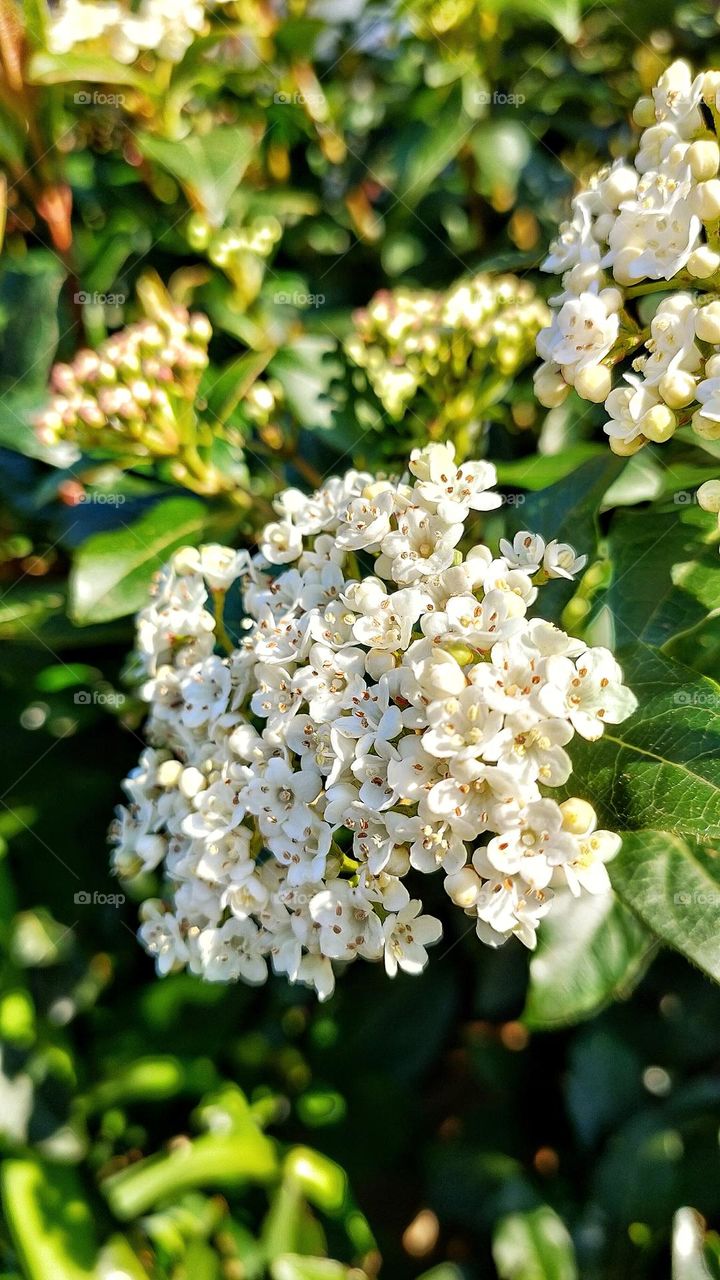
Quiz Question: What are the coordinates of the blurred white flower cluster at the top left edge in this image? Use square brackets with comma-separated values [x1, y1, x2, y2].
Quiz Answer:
[47, 0, 229, 64]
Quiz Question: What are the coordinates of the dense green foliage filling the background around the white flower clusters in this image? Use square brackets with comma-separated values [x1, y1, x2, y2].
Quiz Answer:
[0, 0, 720, 1280]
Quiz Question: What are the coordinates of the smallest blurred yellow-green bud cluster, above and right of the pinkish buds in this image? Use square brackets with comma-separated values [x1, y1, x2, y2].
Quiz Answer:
[186, 214, 282, 307]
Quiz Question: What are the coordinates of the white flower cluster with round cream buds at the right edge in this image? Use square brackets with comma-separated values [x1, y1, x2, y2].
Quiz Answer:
[536, 61, 720, 454]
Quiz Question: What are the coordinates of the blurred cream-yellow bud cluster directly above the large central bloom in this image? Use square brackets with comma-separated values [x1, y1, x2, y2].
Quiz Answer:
[345, 274, 548, 435]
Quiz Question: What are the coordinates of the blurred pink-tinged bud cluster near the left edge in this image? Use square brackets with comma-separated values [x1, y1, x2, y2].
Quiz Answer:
[35, 306, 213, 458]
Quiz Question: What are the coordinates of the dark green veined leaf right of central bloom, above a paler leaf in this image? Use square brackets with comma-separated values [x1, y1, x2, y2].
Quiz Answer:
[569, 644, 720, 838]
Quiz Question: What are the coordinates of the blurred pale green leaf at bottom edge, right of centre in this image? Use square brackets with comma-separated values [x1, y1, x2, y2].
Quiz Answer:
[492, 1204, 578, 1280]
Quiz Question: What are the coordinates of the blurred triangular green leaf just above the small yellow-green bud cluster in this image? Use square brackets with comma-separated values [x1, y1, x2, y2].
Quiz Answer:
[137, 124, 258, 227]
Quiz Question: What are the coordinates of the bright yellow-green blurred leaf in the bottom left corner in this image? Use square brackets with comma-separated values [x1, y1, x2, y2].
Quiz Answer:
[1, 1160, 97, 1280]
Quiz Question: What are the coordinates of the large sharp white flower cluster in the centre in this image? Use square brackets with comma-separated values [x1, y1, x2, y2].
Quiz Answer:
[113, 444, 635, 998]
